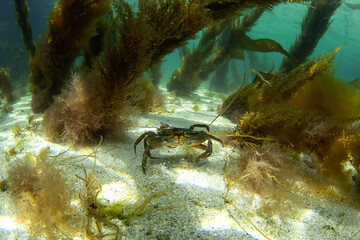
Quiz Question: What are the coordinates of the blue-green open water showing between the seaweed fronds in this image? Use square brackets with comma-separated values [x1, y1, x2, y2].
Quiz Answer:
[0, 0, 360, 88]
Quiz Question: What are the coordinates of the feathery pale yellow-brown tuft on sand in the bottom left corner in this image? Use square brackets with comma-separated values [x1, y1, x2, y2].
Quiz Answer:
[7, 148, 75, 239]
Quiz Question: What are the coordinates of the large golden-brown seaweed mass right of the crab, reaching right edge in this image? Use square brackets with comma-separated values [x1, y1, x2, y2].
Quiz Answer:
[223, 49, 360, 195]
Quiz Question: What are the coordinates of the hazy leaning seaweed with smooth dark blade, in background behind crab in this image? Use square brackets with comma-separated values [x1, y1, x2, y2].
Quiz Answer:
[167, 7, 268, 96]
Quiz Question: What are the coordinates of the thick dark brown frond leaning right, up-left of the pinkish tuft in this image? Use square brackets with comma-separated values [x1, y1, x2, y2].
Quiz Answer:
[30, 0, 110, 113]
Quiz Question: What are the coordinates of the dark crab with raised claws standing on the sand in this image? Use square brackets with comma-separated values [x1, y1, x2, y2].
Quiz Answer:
[134, 124, 224, 174]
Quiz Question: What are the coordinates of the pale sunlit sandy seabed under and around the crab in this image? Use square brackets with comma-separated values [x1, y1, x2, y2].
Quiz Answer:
[0, 89, 360, 240]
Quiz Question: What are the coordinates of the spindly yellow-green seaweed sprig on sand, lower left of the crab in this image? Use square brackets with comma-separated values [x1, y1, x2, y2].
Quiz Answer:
[76, 138, 186, 236]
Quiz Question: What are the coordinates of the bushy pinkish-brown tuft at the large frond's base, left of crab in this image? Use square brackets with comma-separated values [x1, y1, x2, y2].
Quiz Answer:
[43, 70, 134, 145]
